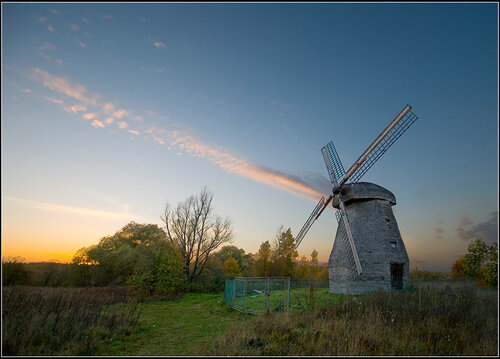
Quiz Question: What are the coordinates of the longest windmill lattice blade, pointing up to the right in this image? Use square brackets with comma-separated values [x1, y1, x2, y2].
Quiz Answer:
[350, 110, 418, 182]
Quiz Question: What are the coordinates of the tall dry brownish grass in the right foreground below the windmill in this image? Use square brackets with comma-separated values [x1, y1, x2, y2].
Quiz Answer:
[207, 287, 498, 356]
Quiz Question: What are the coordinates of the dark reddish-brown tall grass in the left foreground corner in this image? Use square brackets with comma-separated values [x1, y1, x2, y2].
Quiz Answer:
[2, 287, 139, 355]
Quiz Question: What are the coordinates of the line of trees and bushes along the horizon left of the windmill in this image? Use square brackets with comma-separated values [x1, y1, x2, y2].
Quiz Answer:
[2, 188, 328, 295]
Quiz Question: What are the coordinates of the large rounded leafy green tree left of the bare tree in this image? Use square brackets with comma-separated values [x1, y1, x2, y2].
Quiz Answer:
[69, 222, 184, 293]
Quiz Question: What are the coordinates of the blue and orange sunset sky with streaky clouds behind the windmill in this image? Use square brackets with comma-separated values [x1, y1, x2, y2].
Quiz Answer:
[1, 3, 499, 272]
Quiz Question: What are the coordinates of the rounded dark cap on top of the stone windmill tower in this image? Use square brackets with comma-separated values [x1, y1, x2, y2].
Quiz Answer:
[333, 182, 396, 208]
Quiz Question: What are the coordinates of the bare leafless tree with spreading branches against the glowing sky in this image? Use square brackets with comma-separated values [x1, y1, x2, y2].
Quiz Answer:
[161, 188, 232, 282]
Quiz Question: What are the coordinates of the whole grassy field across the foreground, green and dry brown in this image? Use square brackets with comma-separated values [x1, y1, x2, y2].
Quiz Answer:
[2, 282, 498, 356]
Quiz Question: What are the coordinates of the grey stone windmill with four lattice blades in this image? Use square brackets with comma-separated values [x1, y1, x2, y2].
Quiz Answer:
[295, 105, 418, 294]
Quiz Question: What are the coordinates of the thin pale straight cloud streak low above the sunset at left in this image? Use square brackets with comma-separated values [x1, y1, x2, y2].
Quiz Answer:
[2, 196, 145, 221]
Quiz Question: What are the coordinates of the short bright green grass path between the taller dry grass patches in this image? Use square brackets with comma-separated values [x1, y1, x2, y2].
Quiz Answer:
[96, 293, 251, 356]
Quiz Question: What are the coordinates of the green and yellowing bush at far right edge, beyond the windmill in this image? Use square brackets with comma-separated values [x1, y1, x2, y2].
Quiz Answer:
[451, 238, 498, 287]
